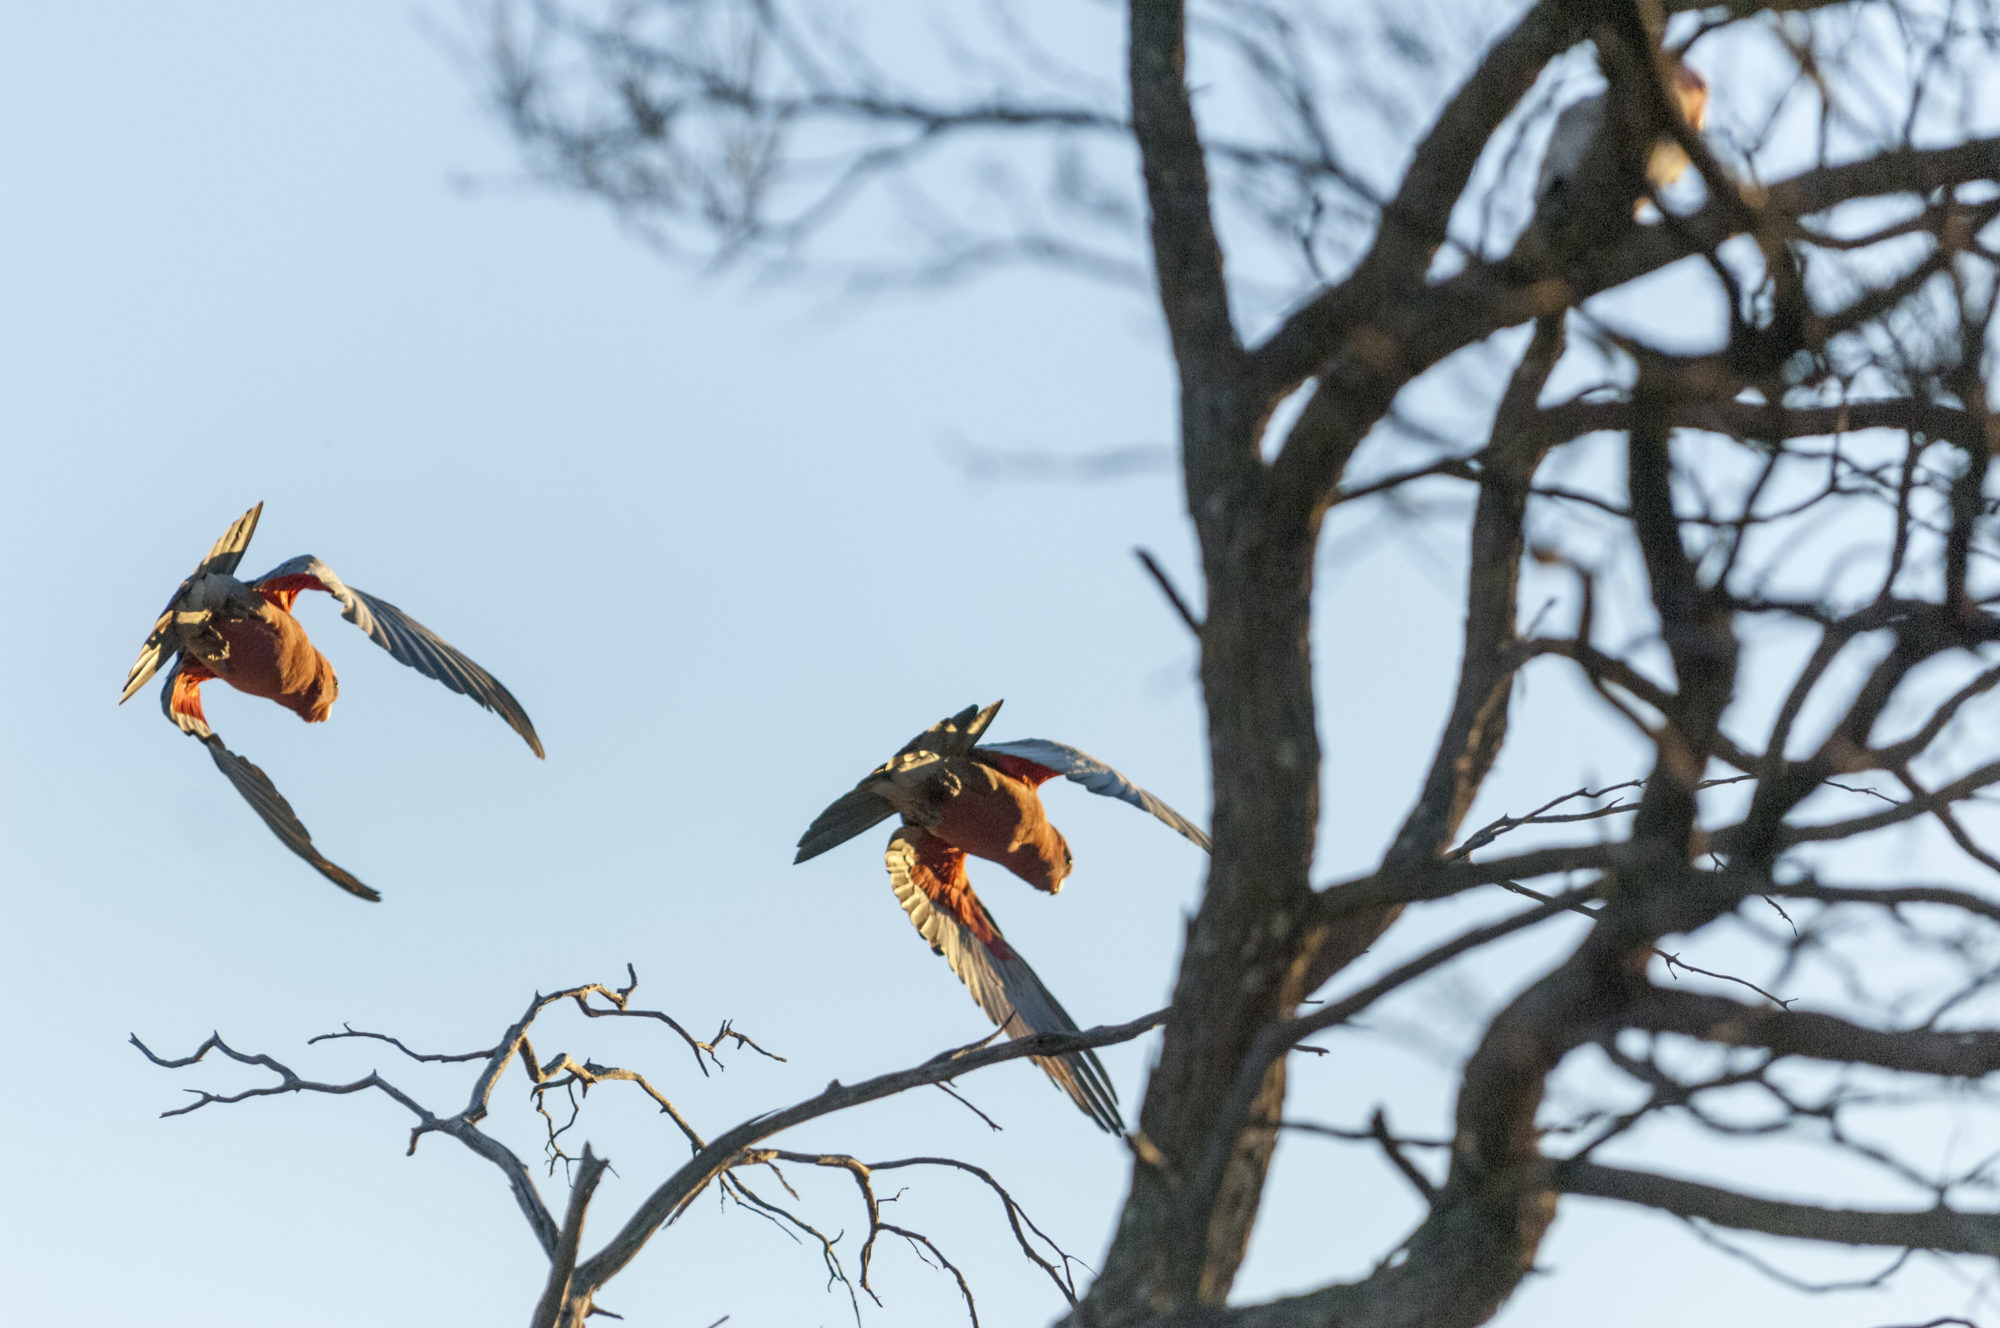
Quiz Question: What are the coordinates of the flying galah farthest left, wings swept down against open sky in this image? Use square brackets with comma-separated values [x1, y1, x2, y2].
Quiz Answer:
[118, 502, 542, 900]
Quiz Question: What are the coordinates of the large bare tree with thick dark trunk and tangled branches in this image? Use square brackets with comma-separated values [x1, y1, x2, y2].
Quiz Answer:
[145, 0, 2000, 1328]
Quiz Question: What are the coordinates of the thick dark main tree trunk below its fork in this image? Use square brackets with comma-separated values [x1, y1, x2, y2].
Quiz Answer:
[1074, 466, 1320, 1324]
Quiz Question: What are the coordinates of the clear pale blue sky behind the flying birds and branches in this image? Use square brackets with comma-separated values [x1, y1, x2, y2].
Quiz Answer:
[0, 0, 1972, 1328]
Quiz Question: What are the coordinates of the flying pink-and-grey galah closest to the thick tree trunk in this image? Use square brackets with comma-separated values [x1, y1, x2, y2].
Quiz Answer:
[794, 702, 1208, 1134]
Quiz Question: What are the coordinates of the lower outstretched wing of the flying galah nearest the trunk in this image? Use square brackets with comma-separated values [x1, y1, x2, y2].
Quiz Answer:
[886, 828, 1124, 1134]
